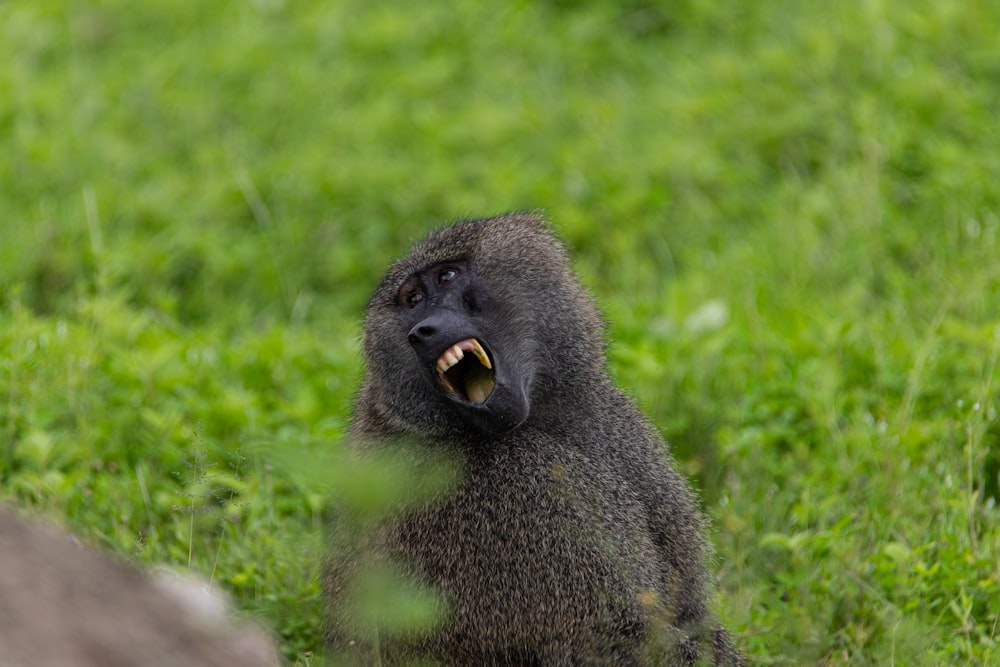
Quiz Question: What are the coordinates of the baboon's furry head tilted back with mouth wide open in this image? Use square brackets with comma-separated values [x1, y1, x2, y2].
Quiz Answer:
[358, 214, 603, 435]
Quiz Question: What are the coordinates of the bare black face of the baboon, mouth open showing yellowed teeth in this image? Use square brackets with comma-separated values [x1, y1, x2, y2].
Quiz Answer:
[396, 259, 529, 433]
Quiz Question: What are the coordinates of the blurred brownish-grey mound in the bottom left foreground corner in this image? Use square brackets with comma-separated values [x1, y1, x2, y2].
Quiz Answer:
[0, 506, 279, 667]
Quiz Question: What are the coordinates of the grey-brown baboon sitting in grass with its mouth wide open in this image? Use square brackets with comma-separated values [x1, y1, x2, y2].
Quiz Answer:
[325, 213, 744, 665]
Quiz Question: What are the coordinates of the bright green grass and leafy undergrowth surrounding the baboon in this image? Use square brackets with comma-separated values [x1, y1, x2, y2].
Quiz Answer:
[0, 0, 1000, 665]
